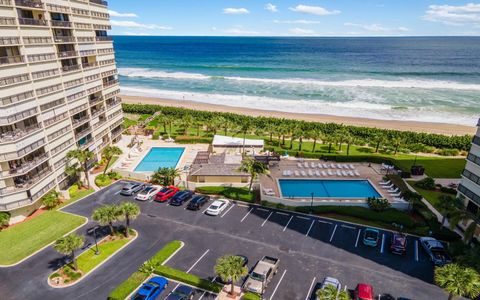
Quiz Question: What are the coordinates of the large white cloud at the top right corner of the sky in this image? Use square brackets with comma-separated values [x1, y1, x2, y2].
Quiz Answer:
[423, 3, 480, 25]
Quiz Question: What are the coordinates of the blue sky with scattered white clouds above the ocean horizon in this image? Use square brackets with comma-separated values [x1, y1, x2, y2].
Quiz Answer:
[109, 0, 480, 36]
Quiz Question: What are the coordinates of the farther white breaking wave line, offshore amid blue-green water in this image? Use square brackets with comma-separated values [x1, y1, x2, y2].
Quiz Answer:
[119, 68, 480, 91]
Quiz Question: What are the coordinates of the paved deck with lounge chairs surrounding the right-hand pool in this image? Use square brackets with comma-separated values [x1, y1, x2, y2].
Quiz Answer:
[260, 159, 397, 205]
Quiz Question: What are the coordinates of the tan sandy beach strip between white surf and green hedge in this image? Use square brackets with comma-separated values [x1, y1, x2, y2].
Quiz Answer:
[120, 95, 476, 135]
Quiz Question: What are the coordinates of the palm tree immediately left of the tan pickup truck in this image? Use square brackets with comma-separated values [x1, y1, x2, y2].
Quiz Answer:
[215, 255, 248, 295]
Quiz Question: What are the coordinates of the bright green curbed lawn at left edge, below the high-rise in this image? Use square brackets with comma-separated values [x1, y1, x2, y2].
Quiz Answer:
[0, 210, 85, 265]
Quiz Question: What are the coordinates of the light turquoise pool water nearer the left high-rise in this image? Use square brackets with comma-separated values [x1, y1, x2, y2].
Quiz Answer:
[135, 148, 185, 172]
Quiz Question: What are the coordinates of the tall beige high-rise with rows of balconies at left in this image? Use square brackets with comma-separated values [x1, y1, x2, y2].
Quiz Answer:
[0, 0, 122, 222]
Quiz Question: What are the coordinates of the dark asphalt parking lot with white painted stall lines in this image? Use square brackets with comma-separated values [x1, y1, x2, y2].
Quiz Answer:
[0, 183, 445, 300]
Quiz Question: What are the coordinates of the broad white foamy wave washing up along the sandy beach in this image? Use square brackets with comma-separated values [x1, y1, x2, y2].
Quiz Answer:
[121, 85, 477, 126]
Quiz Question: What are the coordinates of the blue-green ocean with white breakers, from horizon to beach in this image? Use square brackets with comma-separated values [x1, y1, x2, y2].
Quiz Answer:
[114, 36, 480, 126]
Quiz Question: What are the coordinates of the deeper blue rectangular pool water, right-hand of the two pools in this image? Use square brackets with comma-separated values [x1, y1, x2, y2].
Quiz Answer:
[279, 179, 381, 199]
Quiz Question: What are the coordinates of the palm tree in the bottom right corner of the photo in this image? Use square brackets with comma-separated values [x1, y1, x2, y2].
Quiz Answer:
[435, 264, 480, 300]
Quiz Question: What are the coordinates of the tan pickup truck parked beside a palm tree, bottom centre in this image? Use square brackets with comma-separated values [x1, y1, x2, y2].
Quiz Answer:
[243, 256, 280, 295]
